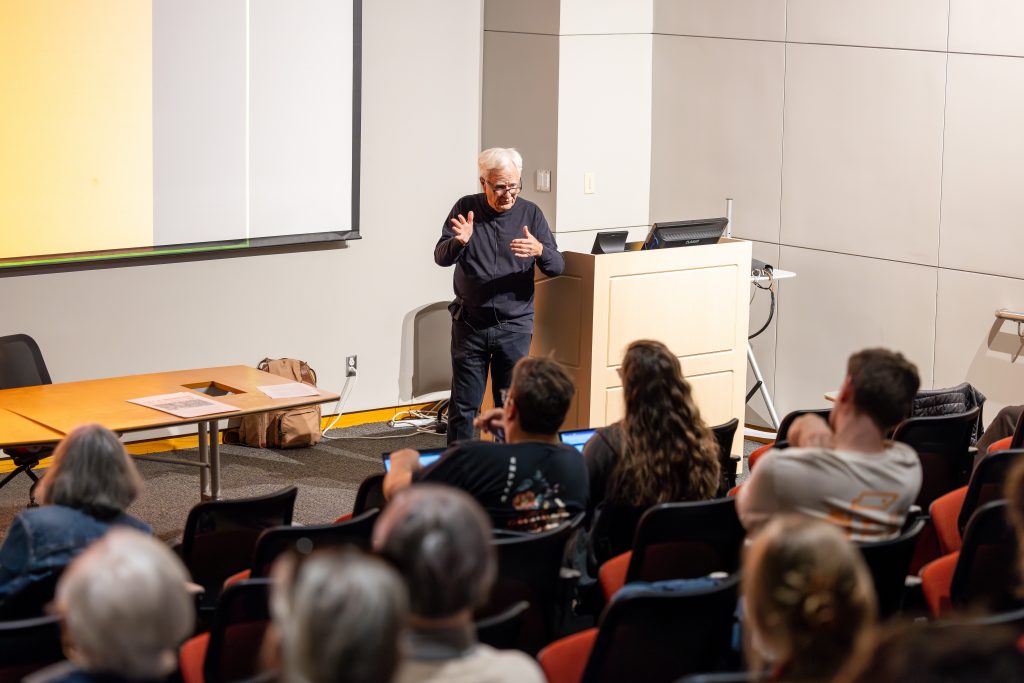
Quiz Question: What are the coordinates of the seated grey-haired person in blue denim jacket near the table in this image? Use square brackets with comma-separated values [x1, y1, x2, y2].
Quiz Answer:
[0, 425, 150, 604]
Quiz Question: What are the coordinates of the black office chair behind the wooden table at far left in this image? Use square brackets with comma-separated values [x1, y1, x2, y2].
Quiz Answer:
[0, 335, 53, 505]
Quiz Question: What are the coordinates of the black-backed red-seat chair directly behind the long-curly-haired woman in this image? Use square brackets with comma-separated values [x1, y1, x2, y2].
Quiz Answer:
[598, 498, 745, 601]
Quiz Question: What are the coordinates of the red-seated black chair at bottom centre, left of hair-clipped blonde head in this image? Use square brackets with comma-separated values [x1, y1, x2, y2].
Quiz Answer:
[538, 573, 739, 683]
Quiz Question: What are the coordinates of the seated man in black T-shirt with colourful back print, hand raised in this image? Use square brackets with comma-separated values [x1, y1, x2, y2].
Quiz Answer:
[384, 358, 588, 531]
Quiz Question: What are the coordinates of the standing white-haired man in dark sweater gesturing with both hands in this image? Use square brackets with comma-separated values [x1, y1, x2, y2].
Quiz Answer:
[434, 147, 565, 444]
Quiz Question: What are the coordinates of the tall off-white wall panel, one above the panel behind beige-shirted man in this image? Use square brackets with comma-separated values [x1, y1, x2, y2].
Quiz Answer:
[781, 44, 946, 264]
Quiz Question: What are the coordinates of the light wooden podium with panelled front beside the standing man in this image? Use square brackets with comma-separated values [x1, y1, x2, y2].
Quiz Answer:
[530, 239, 751, 454]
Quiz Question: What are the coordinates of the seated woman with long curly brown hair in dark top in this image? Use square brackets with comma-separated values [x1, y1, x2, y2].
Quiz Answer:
[584, 340, 720, 516]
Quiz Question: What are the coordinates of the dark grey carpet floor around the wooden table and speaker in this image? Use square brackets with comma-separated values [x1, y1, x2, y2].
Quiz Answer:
[0, 423, 760, 542]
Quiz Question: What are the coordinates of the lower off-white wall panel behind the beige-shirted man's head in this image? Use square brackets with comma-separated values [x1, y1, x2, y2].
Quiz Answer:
[775, 246, 937, 414]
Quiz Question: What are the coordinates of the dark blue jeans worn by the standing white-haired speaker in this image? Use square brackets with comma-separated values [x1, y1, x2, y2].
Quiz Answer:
[447, 319, 534, 444]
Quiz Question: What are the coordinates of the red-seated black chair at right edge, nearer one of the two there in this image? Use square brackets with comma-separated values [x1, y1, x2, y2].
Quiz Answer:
[921, 501, 1020, 617]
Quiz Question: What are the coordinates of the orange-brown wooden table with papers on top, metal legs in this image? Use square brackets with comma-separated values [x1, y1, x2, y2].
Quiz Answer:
[0, 366, 338, 500]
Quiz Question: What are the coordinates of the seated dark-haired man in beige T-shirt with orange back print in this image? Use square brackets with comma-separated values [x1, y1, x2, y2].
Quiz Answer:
[736, 348, 922, 541]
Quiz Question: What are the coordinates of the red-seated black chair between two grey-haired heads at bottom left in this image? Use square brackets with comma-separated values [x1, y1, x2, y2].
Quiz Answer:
[178, 579, 270, 683]
